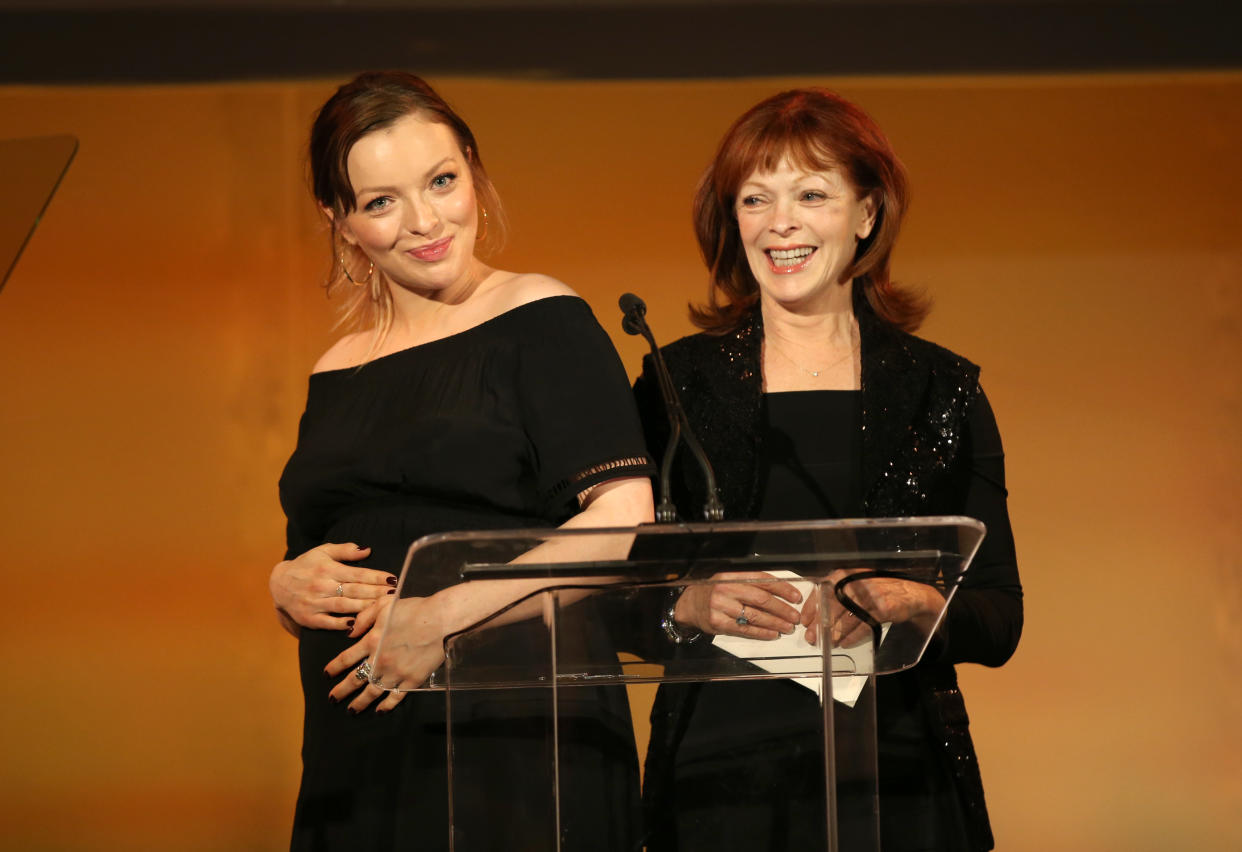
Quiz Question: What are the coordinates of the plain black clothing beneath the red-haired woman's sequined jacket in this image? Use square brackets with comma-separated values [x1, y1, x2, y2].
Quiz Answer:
[652, 391, 1017, 852]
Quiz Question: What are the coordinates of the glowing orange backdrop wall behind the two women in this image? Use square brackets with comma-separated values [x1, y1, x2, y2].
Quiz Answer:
[0, 73, 1242, 852]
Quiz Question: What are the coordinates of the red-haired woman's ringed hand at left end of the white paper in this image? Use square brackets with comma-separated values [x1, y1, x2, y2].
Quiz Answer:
[673, 571, 802, 640]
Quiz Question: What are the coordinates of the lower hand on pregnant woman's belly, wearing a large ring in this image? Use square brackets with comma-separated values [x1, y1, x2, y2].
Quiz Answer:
[323, 597, 445, 713]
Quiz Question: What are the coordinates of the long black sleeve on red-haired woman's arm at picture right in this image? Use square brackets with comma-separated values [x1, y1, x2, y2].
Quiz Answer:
[938, 390, 1022, 666]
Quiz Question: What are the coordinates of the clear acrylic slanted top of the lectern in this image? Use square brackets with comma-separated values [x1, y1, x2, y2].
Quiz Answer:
[362, 517, 984, 699]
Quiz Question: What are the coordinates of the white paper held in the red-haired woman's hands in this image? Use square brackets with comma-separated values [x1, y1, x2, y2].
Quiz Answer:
[712, 571, 888, 707]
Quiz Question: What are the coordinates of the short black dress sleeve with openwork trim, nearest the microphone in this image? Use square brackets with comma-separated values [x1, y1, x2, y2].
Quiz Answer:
[518, 298, 653, 508]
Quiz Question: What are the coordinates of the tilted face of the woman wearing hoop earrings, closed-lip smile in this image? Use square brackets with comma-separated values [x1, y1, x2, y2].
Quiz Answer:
[338, 114, 478, 298]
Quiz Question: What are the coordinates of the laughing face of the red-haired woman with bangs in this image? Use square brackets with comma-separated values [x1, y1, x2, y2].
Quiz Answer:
[734, 159, 876, 312]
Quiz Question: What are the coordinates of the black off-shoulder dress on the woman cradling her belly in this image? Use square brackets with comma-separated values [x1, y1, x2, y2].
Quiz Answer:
[281, 296, 651, 851]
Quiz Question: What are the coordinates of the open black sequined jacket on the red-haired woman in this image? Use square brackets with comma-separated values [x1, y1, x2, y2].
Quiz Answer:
[635, 299, 1021, 850]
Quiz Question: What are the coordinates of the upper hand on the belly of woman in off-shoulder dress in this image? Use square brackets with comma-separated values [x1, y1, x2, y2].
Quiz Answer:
[268, 543, 396, 636]
